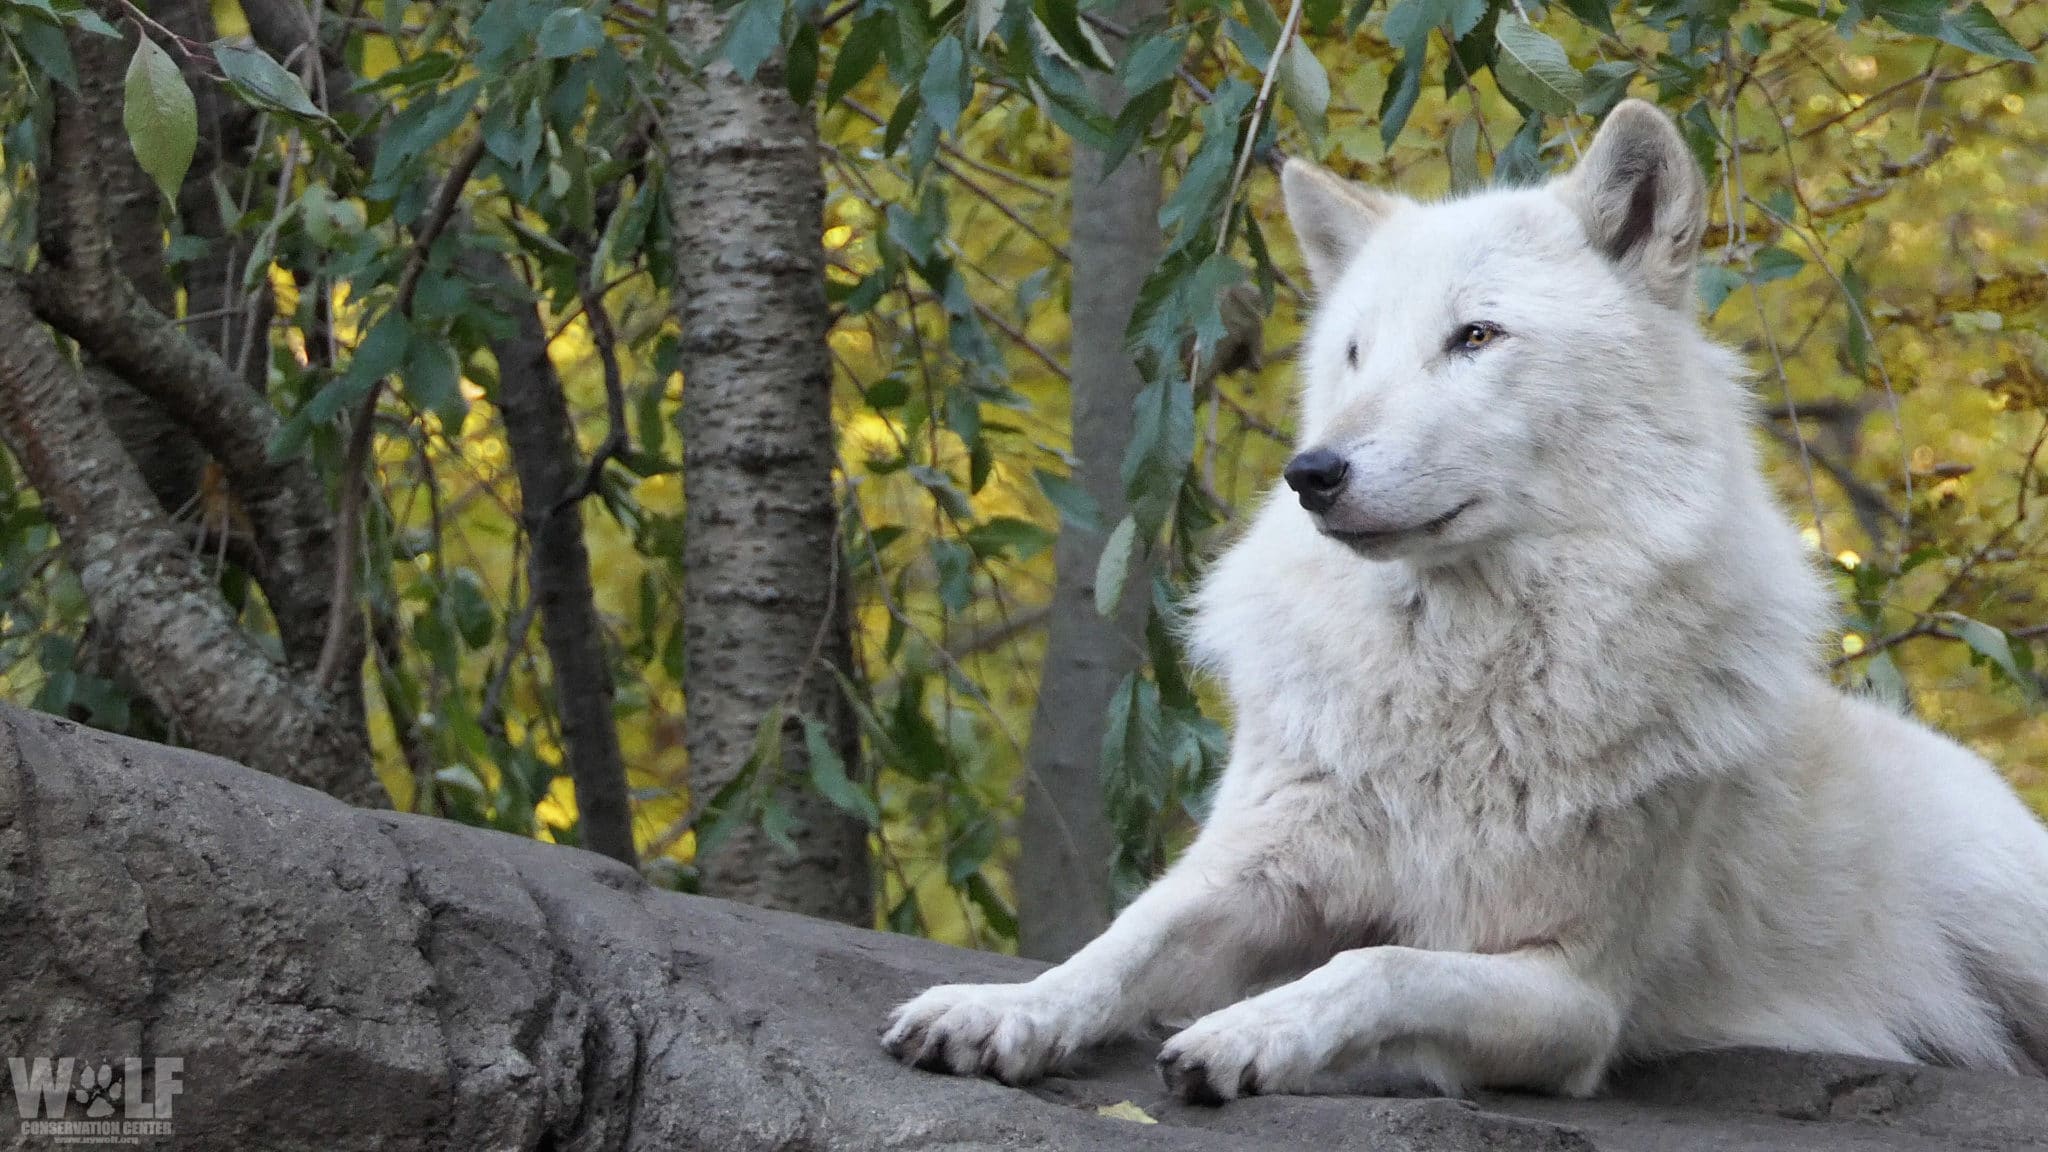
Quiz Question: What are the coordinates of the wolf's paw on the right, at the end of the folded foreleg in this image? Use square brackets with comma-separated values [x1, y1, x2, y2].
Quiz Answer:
[1159, 1000, 1329, 1105]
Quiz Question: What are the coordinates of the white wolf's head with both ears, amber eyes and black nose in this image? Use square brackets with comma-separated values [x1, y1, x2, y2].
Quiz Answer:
[1282, 100, 1706, 560]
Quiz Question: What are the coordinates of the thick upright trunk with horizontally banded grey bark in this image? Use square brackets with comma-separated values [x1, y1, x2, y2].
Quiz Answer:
[662, 0, 872, 924]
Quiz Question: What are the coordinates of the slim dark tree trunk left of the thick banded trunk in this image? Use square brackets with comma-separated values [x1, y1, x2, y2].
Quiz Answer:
[492, 282, 637, 867]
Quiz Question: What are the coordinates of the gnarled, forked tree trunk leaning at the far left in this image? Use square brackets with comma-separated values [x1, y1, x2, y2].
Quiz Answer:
[0, 11, 385, 804]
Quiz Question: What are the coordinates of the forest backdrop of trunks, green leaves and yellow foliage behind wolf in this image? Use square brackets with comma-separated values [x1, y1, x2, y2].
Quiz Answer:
[0, 0, 2048, 957]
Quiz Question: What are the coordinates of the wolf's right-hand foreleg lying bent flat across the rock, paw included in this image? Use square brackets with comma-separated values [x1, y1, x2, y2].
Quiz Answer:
[1159, 947, 1622, 1103]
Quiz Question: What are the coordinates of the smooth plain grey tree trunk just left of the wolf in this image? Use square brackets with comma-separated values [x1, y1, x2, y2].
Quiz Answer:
[1016, 0, 1161, 959]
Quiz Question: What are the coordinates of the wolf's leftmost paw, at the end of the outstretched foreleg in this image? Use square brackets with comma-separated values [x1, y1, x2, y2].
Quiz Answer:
[883, 982, 1104, 1084]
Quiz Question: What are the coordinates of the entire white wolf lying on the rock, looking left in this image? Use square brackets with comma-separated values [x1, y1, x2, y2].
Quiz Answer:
[885, 102, 2048, 1103]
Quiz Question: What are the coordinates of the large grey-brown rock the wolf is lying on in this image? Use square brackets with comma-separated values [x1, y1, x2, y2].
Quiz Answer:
[0, 709, 2048, 1152]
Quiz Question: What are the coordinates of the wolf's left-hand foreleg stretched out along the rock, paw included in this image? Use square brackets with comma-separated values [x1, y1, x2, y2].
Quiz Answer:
[883, 807, 1327, 1082]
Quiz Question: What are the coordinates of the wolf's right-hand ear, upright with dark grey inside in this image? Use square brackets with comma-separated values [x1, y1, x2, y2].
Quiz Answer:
[1563, 100, 1706, 312]
